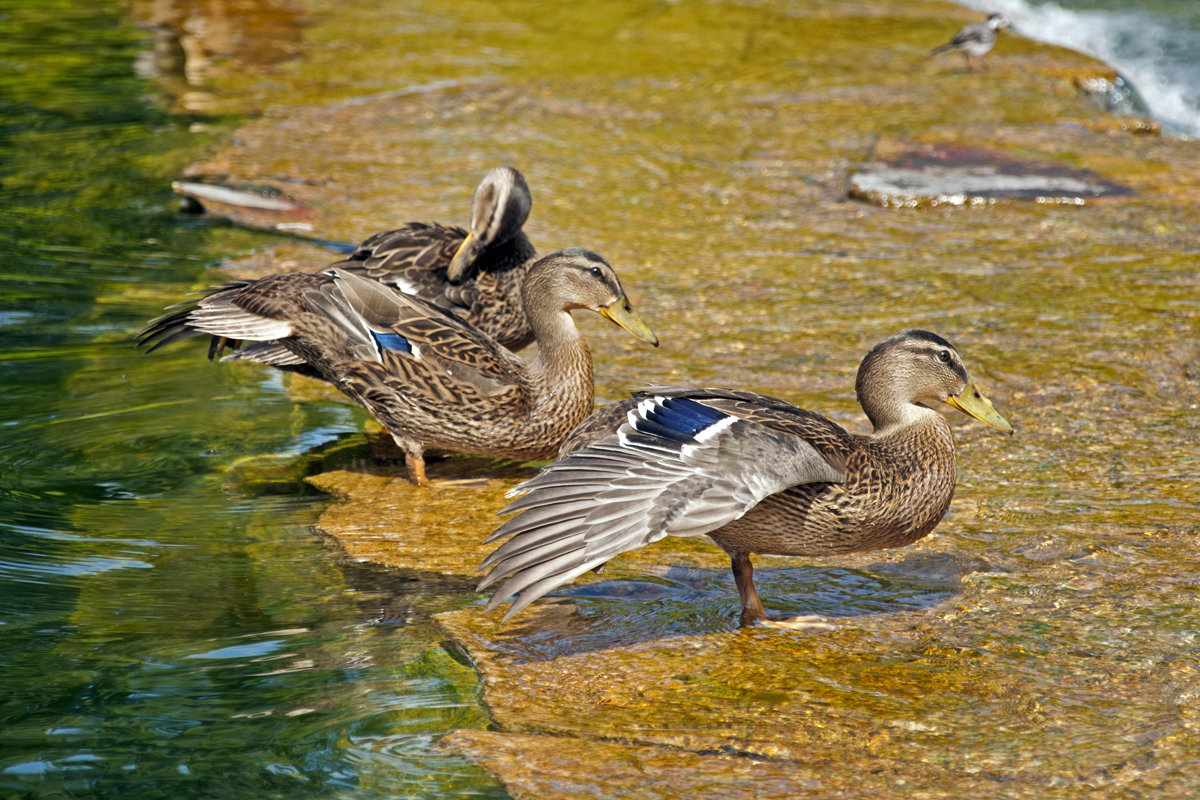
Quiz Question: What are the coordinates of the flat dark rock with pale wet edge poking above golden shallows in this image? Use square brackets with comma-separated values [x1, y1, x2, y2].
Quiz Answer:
[850, 142, 1133, 207]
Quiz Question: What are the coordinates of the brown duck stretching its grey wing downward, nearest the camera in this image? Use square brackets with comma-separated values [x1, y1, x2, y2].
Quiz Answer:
[479, 330, 1013, 625]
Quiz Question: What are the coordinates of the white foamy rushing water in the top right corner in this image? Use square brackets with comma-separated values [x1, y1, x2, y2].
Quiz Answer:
[964, 0, 1200, 138]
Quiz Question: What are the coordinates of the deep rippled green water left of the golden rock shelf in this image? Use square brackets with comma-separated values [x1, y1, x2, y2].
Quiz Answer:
[0, 1, 504, 799]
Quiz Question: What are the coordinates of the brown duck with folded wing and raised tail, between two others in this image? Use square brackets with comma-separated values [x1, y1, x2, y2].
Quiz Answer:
[139, 247, 658, 485]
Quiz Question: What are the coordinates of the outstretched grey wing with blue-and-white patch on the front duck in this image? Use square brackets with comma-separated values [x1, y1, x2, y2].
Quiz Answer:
[479, 390, 845, 619]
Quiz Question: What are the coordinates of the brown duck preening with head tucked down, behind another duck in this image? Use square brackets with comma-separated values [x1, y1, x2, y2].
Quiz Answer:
[331, 167, 535, 350]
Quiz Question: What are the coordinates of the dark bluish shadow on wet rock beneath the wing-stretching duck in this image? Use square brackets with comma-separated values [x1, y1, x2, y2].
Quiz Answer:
[488, 554, 991, 663]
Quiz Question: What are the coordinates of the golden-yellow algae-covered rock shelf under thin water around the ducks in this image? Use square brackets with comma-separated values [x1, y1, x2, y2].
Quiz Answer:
[133, 0, 1200, 798]
